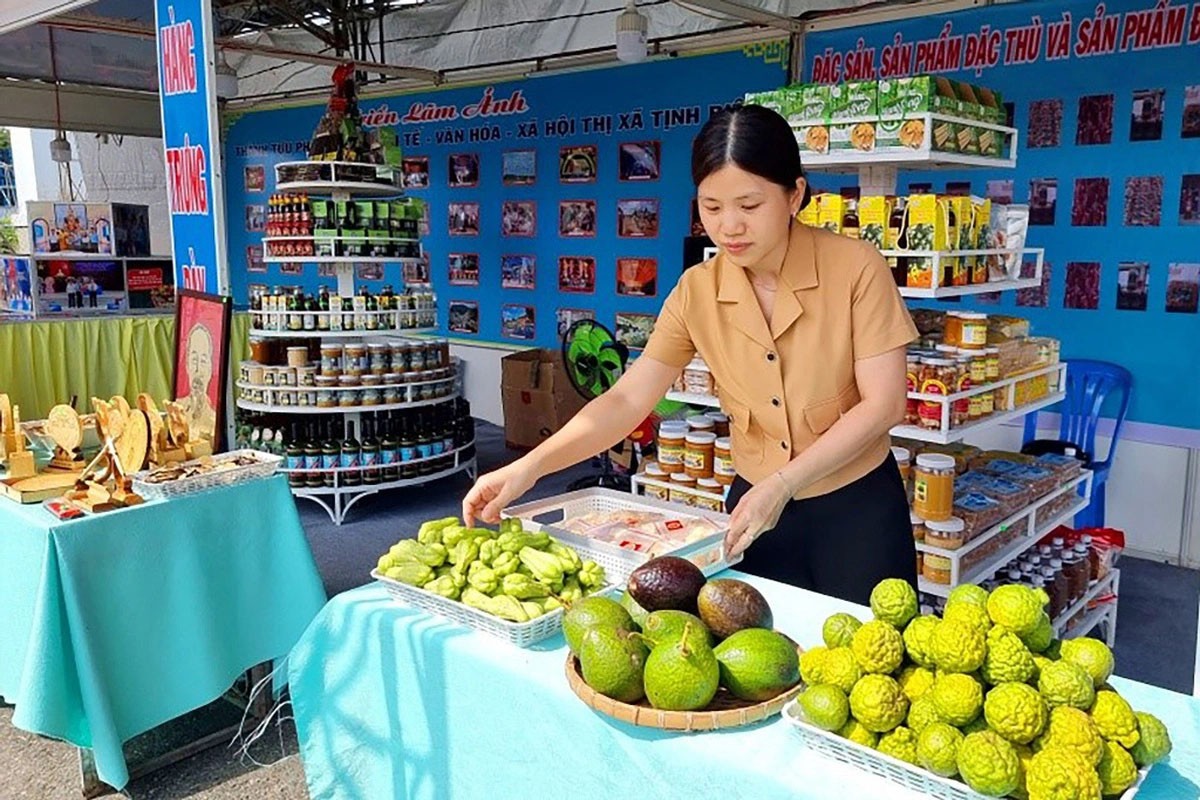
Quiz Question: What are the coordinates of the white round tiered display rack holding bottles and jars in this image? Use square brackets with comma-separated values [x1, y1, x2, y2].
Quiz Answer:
[236, 162, 478, 525]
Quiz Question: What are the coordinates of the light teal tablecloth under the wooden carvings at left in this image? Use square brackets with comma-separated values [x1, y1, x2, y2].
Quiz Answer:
[0, 476, 325, 794]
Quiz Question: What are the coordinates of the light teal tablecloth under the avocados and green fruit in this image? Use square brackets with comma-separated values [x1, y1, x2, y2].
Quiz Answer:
[288, 567, 1200, 800]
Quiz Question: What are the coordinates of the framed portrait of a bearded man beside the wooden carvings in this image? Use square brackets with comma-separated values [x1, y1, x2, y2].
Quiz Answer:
[170, 289, 233, 452]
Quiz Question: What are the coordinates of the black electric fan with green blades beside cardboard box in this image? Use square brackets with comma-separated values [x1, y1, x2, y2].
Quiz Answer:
[563, 319, 629, 492]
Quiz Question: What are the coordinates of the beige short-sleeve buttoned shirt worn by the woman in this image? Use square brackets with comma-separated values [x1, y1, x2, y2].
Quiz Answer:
[644, 223, 917, 498]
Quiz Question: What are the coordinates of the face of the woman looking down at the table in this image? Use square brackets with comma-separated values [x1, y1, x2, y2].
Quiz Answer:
[696, 164, 804, 267]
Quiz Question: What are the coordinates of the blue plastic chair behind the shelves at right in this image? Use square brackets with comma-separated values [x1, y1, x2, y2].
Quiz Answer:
[1025, 359, 1133, 528]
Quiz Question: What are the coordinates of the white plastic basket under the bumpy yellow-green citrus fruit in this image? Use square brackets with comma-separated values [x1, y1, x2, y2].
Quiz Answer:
[782, 699, 1151, 800]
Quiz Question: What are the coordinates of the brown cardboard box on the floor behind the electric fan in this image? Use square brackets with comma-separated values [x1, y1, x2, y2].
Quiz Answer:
[500, 349, 587, 450]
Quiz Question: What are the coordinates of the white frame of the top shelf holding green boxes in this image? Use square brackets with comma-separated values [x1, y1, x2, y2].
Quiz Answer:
[792, 113, 1018, 173]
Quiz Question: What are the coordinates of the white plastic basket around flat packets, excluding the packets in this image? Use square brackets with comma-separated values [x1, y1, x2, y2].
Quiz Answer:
[500, 488, 742, 583]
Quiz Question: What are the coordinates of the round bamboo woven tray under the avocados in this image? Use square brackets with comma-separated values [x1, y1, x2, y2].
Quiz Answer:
[565, 655, 803, 732]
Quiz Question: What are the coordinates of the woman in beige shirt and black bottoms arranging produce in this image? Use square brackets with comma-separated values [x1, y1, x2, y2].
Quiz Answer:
[463, 106, 917, 603]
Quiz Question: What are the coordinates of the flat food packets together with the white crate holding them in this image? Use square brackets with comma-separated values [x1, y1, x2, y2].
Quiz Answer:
[502, 488, 740, 583]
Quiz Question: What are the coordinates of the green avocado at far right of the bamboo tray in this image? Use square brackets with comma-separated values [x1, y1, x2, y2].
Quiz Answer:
[713, 627, 800, 703]
